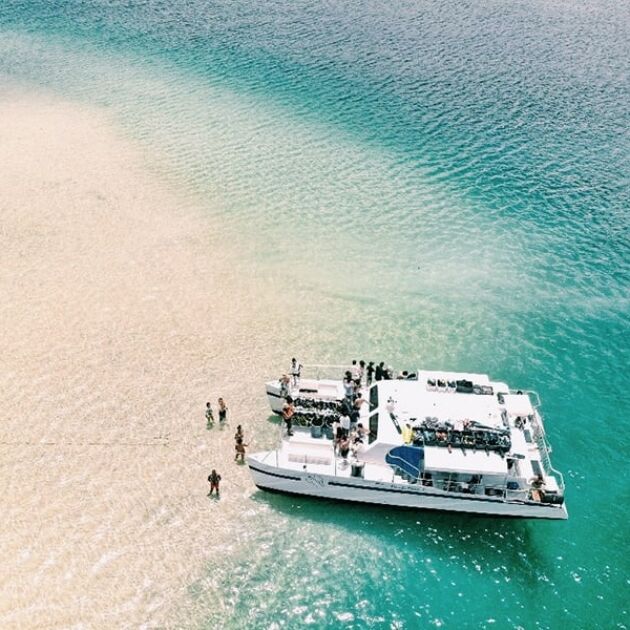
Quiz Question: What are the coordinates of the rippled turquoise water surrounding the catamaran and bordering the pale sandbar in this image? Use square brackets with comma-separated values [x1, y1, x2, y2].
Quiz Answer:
[0, 0, 630, 628]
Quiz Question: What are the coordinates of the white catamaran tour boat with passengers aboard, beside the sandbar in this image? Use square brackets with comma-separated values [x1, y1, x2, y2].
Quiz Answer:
[247, 366, 567, 519]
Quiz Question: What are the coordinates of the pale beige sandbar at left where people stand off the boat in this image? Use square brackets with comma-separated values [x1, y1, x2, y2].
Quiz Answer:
[0, 90, 288, 628]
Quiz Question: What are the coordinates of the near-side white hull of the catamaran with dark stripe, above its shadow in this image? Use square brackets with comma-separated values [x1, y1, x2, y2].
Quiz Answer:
[247, 455, 567, 519]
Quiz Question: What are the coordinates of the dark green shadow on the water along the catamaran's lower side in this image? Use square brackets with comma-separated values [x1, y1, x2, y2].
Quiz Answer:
[251, 490, 558, 586]
